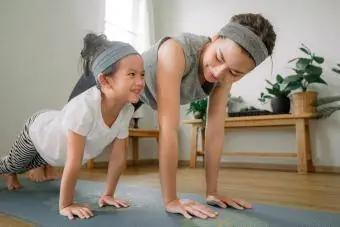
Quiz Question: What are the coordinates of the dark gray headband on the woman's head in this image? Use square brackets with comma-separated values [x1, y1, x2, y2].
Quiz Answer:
[218, 22, 268, 65]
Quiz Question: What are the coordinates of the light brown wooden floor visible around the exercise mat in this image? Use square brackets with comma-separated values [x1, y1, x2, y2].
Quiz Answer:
[0, 167, 340, 227]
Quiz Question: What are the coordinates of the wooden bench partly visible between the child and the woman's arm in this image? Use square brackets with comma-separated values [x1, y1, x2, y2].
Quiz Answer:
[86, 128, 159, 169]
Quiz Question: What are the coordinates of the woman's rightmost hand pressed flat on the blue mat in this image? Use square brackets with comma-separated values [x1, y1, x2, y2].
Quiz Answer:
[207, 195, 251, 210]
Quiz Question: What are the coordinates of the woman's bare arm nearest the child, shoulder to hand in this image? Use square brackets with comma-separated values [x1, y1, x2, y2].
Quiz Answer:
[156, 39, 216, 218]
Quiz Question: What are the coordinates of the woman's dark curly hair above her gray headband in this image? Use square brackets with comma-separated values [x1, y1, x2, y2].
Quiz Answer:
[230, 13, 276, 55]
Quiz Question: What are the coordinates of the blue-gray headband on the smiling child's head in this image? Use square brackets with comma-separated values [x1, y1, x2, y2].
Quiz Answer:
[91, 41, 140, 77]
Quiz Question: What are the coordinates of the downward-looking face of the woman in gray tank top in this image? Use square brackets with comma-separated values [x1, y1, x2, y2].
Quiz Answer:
[201, 38, 255, 83]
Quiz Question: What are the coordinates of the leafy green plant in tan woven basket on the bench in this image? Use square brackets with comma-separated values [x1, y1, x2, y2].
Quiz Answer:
[284, 44, 327, 114]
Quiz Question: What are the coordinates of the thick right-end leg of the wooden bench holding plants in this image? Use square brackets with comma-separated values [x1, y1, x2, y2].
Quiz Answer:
[295, 119, 311, 174]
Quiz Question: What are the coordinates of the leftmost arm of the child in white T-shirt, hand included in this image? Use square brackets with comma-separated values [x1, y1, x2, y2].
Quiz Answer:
[59, 131, 93, 219]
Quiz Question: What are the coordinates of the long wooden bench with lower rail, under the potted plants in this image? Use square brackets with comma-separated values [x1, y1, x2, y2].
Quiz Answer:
[184, 114, 314, 173]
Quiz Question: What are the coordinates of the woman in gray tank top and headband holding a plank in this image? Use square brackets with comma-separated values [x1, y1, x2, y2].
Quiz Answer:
[36, 13, 276, 218]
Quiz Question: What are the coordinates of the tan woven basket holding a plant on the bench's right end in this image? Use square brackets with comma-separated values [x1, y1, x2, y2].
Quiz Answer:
[292, 91, 317, 115]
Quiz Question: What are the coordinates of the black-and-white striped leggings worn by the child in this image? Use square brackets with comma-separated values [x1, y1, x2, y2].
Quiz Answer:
[0, 112, 47, 174]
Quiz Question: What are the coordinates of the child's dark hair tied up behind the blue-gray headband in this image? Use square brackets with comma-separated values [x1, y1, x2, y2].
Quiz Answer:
[80, 33, 119, 76]
